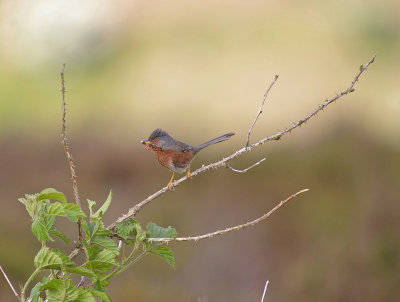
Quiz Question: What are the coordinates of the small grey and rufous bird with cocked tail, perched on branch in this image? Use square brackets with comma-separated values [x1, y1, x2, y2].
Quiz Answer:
[140, 128, 235, 190]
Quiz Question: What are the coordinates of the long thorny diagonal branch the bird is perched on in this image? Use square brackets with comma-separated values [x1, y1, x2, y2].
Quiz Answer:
[108, 54, 376, 229]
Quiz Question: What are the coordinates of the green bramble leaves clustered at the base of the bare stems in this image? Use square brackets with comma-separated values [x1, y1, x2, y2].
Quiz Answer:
[19, 188, 177, 302]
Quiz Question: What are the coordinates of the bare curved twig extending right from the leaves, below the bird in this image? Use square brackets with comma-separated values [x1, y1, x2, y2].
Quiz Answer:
[146, 189, 309, 243]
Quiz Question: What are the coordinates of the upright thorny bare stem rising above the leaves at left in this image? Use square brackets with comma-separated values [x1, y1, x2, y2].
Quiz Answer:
[61, 64, 82, 243]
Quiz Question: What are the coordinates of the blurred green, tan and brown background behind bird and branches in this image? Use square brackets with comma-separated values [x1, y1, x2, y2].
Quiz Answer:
[0, 0, 400, 302]
